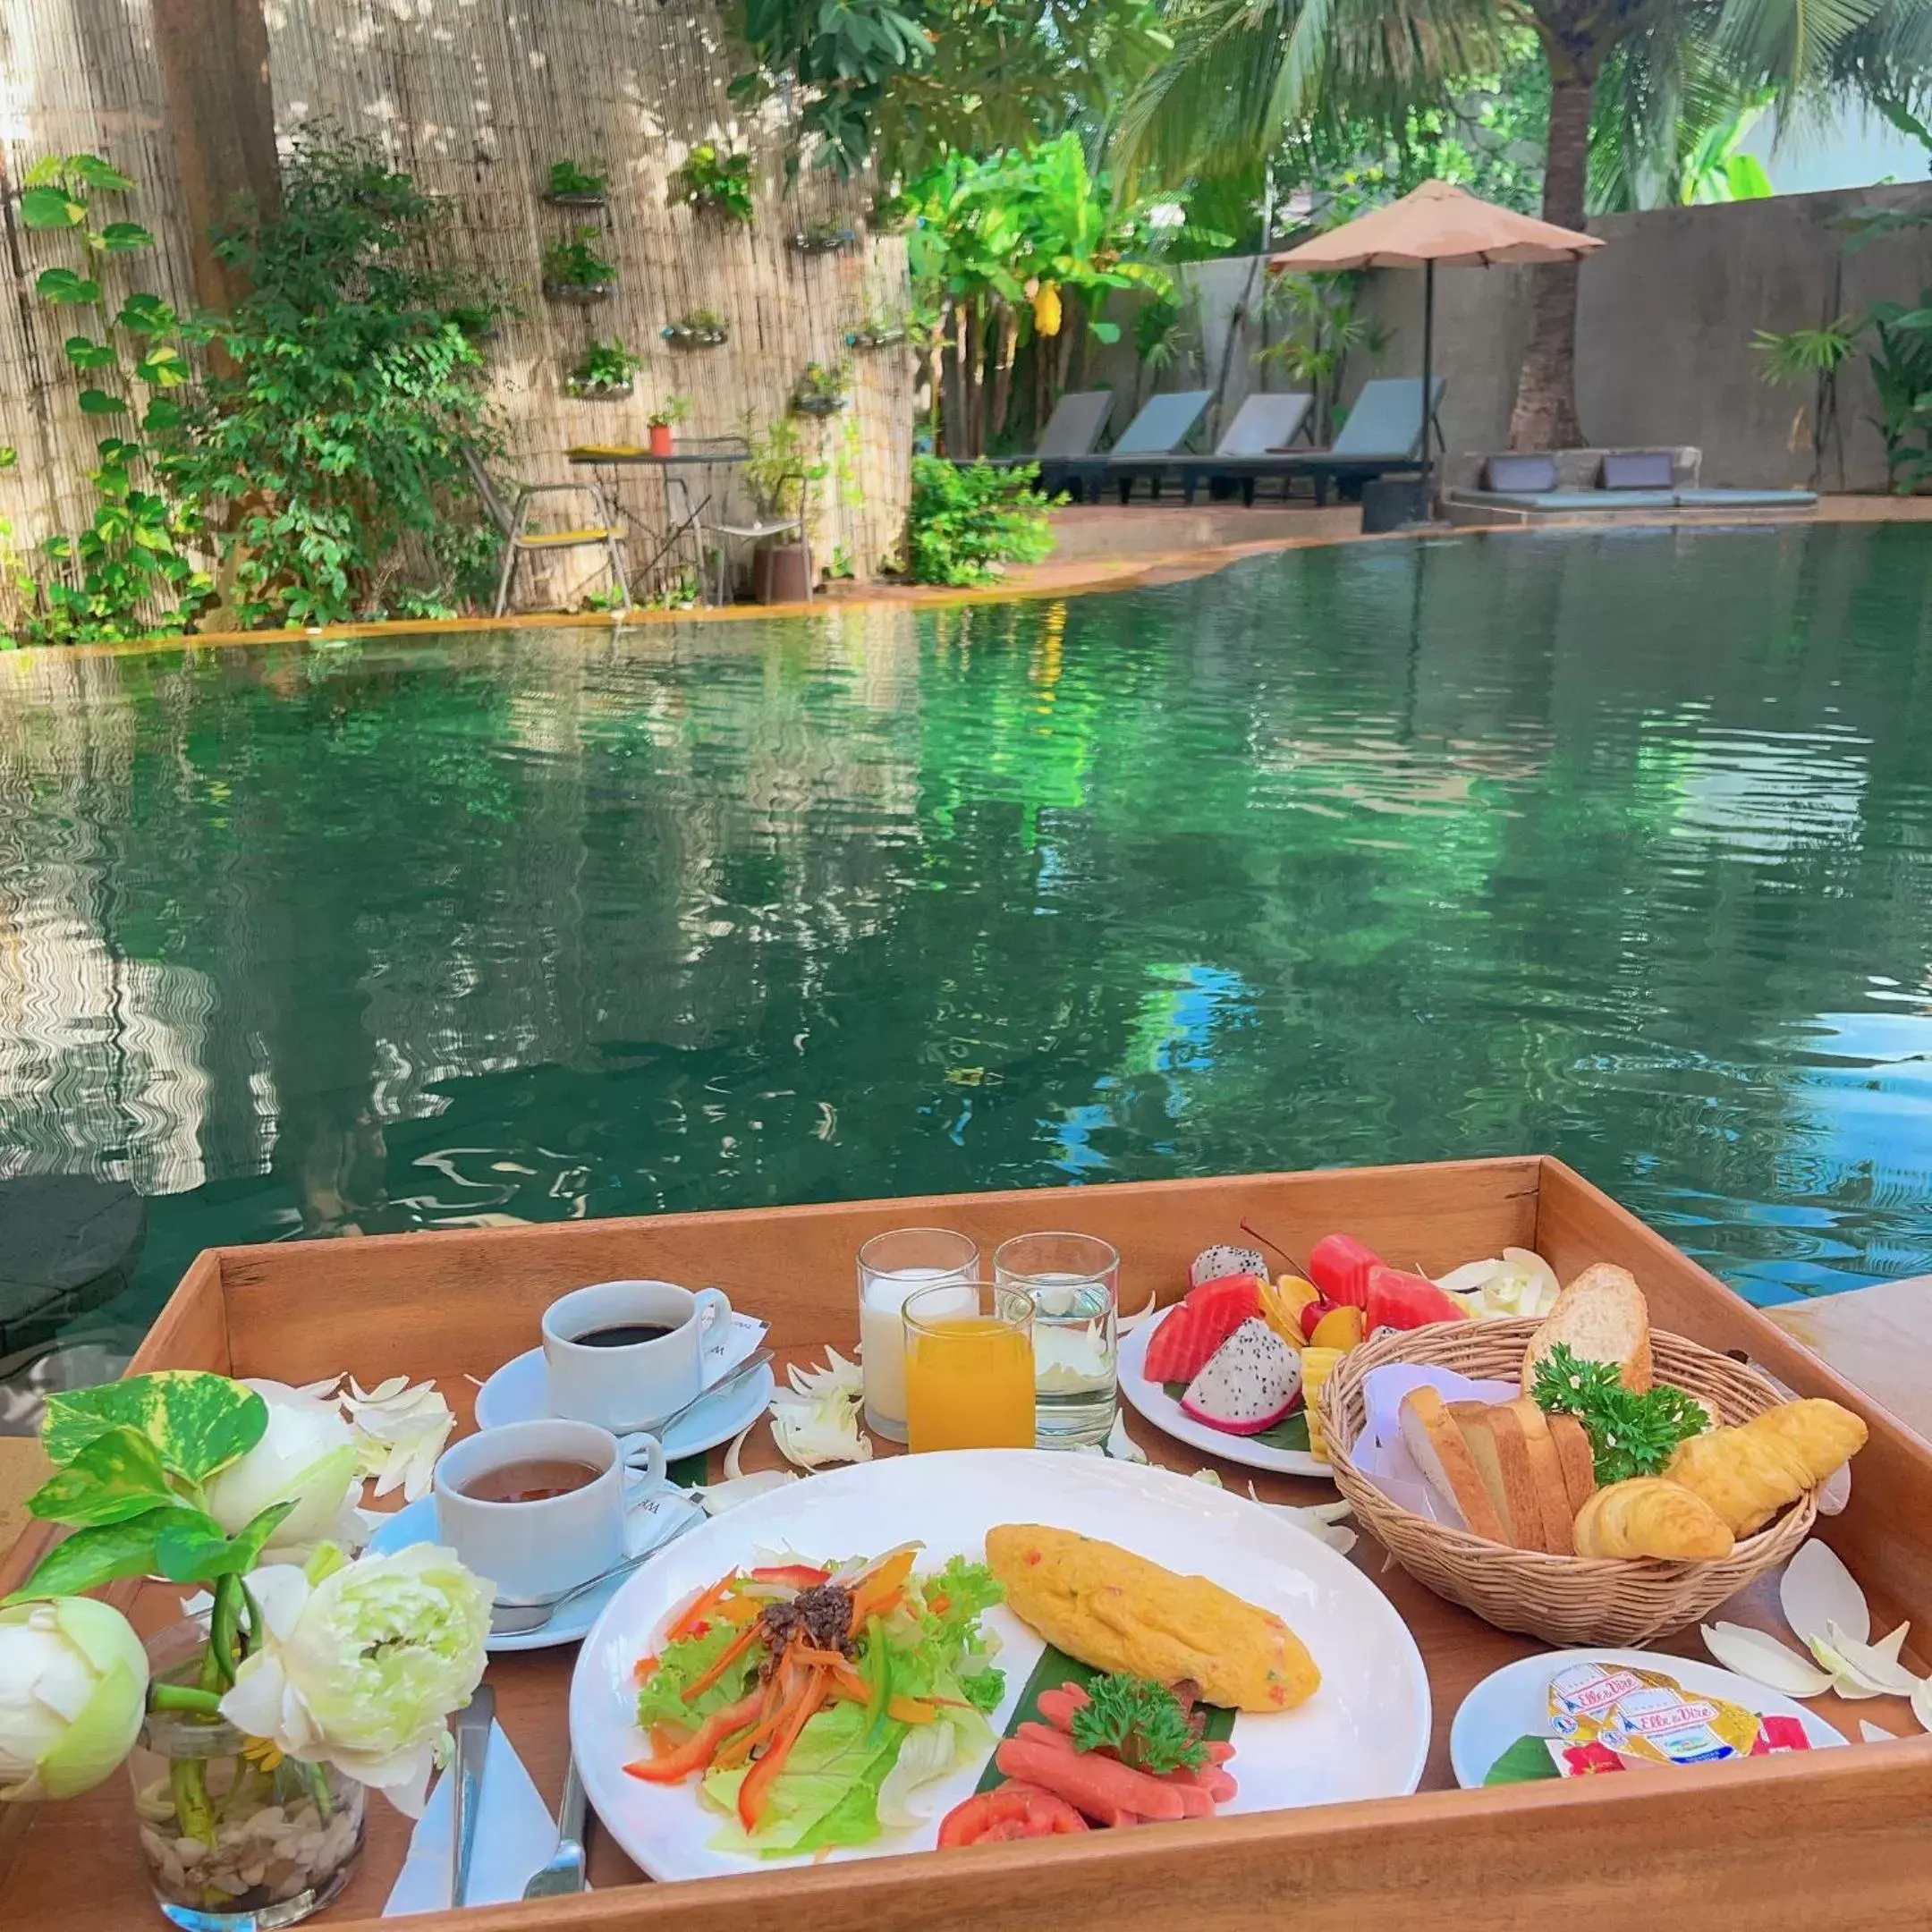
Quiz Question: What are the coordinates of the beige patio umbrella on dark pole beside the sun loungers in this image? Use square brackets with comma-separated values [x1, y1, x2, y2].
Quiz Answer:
[1267, 182, 1604, 504]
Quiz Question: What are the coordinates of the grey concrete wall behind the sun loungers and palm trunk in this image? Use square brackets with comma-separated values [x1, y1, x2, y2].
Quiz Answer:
[1096, 185, 1932, 491]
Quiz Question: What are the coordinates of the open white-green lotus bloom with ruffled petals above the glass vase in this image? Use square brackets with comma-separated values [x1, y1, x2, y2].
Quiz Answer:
[222, 1544, 493, 1818]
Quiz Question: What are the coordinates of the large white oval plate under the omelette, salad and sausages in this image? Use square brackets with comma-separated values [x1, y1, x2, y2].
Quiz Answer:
[570, 1449, 1429, 1878]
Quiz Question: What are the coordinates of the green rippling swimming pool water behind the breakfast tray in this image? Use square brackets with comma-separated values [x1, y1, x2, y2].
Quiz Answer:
[0, 528, 1932, 1360]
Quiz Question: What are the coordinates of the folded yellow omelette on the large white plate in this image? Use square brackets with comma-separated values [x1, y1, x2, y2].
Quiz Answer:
[986, 1522, 1321, 1712]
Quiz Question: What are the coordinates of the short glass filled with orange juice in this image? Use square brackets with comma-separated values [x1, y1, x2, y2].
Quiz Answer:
[904, 1281, 1034, 1453]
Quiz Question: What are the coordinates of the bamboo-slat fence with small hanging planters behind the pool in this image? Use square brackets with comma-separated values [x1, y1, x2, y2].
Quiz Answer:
[0, 0, 916, 618]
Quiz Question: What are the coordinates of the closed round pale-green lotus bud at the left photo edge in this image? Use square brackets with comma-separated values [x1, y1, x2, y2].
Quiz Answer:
[0, 1596, 147, 1801]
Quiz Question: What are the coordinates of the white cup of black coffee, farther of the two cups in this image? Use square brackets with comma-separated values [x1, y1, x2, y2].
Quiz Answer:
[543, 1281, 730, 1429]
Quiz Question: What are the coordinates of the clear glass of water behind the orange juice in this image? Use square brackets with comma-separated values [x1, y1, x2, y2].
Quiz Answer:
[993, 1234, 1121, 1449]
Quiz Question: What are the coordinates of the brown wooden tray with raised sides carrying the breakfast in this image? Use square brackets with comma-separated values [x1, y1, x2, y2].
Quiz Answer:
[0, 1157, 1932, 1932]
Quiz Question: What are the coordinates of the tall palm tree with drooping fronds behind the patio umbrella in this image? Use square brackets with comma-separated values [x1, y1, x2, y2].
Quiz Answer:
[1114, 0, 1932, 448]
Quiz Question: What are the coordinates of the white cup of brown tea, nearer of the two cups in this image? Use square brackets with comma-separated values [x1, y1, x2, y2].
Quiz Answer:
[431, 1422, 665, 1596]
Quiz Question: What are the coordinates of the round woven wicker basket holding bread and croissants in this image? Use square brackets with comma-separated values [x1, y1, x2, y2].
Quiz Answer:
[1321, 1321, 1818, 1646]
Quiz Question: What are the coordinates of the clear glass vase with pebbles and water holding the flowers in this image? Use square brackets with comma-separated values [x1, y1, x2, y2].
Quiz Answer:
[128, 1625, 365, 1932]
